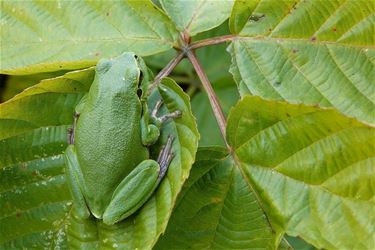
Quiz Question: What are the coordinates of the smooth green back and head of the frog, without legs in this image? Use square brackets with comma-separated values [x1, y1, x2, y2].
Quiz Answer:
[75, 54, 148, 217]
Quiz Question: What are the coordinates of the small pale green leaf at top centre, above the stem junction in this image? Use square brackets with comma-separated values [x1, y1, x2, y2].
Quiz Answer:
[160, 0, 233, 36]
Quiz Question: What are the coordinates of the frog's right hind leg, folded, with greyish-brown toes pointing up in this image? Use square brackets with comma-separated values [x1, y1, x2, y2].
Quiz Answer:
[103, 136, 173, 225]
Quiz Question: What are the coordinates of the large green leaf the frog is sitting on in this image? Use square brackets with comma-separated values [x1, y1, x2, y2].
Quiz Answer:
[0, 72, 199, 249]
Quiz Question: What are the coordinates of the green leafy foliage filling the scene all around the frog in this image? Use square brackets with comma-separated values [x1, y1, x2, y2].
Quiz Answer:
[0, 0, 375, 249]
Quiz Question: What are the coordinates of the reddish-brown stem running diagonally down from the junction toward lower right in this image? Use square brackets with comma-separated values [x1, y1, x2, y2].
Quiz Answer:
[187, 50, 231, 151]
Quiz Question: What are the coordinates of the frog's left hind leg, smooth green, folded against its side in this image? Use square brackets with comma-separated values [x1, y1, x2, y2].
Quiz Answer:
[64, 144, 90, 219]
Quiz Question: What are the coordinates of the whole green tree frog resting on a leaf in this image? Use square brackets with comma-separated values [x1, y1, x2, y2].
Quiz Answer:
[65, 53, 181, 225]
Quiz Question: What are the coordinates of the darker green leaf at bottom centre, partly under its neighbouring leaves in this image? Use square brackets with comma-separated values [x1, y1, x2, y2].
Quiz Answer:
[156, 148, 275, 249]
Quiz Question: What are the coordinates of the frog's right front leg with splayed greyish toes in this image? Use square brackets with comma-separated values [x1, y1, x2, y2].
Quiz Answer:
[141, 100, 182, 146]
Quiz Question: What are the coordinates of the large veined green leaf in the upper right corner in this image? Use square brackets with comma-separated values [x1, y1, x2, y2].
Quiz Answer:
[229, 0, 375, 123]
